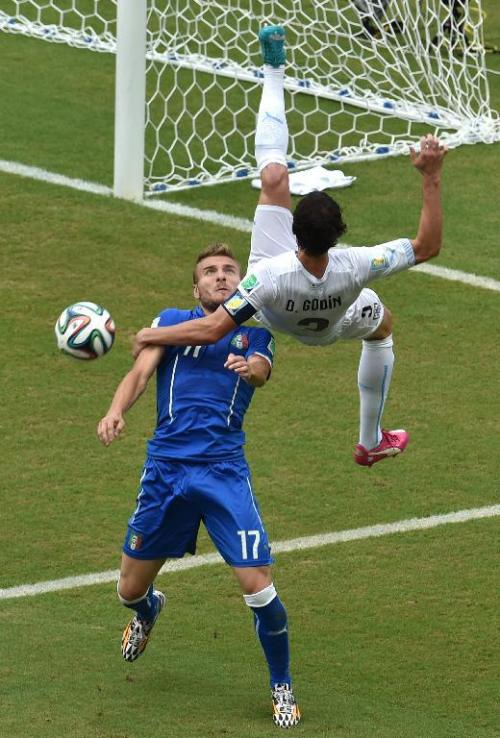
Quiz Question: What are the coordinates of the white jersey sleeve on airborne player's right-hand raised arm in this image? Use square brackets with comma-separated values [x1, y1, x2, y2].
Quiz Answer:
[352, 238, 415, 286]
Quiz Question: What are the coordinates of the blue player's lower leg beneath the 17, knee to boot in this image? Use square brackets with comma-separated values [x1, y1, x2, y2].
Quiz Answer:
[233, 566, 300, 728]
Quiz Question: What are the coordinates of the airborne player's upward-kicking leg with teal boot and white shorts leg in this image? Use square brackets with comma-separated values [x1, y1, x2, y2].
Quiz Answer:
[248, 26, 297, 269]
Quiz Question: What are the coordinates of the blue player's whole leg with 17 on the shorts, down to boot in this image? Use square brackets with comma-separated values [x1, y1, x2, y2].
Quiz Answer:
[203, 461, 300, 728]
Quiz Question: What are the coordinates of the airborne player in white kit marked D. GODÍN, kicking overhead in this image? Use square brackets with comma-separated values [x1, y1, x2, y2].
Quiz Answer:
[134, 26, 447, 466]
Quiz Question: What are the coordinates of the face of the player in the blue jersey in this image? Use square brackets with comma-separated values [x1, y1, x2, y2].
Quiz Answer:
[194, 256, 241, 312]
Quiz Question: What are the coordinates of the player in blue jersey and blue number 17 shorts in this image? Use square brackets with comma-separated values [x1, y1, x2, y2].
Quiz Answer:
[97, 244, 300, 728]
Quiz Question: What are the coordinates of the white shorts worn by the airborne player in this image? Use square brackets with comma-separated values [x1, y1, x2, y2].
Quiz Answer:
[247, 205, 384, 345]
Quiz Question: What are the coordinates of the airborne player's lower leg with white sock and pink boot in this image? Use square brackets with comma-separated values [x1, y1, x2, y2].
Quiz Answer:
[354, 308, 409, 466]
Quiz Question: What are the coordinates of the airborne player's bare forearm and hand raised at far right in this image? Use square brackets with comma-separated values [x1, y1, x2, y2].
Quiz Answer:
[410, 135, 448, 264]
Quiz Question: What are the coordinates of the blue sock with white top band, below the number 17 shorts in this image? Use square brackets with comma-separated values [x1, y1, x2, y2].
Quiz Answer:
[243, 584, 292, 687]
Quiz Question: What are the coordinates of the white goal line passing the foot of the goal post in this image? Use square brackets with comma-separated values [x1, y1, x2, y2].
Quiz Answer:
[0, 159, 500, 292]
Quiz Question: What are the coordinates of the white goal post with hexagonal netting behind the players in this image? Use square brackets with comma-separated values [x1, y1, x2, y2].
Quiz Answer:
[0, 0, 500, 199]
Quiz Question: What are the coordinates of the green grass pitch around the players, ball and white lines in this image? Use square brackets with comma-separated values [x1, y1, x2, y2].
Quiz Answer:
[0, 5, 500, 738]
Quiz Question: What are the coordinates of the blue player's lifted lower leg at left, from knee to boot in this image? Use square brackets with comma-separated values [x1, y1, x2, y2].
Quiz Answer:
[117, 553, 166, 661]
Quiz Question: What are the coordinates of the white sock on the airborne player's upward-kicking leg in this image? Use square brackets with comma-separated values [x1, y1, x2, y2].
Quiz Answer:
[255, 64, 288, 172]
